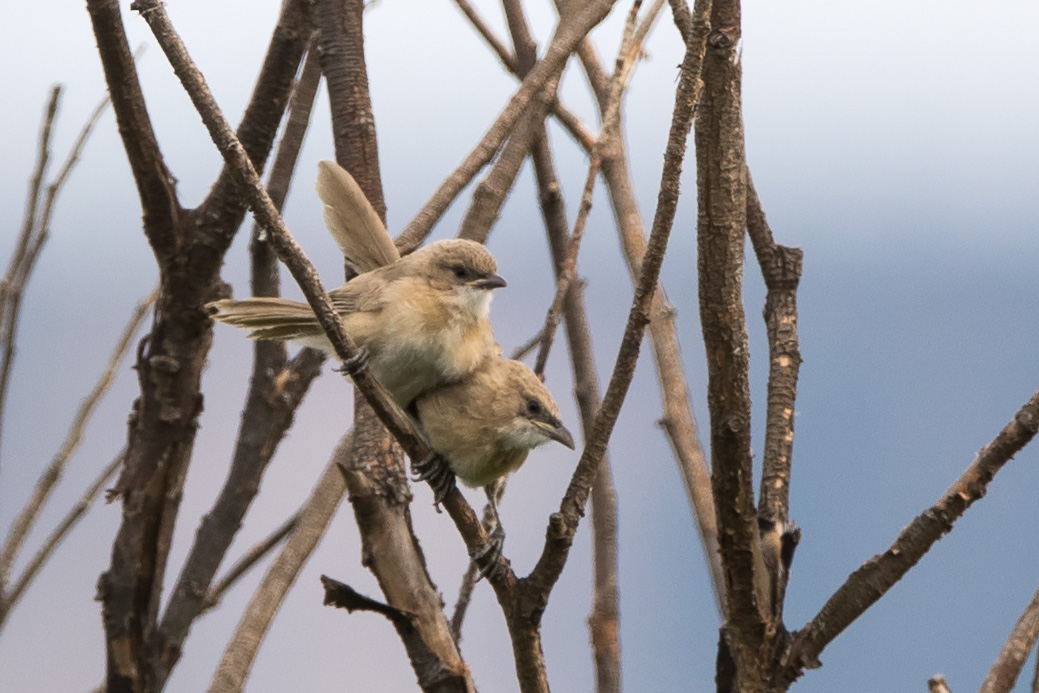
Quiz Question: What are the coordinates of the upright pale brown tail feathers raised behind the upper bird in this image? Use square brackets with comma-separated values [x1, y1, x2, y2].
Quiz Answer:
[317, 161, 400, 273]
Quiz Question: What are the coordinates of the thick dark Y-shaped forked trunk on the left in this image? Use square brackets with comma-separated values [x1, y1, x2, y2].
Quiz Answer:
[93, 0, 305, 691]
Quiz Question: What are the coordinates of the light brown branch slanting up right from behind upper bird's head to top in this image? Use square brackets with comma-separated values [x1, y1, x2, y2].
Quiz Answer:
[397, 0, 616, 250]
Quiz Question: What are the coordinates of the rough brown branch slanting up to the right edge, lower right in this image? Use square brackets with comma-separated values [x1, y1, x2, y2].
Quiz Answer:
[777, 392, 1039, 685]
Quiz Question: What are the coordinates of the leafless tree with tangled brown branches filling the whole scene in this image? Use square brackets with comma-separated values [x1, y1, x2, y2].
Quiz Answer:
[0, 0, 1039, 693]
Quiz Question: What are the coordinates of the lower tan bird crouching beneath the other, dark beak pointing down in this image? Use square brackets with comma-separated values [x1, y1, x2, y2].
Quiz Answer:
[411, 353, 574, 576]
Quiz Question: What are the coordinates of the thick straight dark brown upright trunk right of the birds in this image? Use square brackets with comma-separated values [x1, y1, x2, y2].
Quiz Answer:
[696, 0, 768, 691]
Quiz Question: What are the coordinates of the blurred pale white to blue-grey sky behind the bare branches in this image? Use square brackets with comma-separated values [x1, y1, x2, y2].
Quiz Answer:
[0, 0, 1039, 693]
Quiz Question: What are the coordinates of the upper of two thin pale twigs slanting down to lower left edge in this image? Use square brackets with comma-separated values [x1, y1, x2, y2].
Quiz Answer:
[0, 291, 157, 585]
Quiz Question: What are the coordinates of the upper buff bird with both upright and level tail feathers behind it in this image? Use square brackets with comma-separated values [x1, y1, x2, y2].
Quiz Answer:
[207, 162, 506, 410]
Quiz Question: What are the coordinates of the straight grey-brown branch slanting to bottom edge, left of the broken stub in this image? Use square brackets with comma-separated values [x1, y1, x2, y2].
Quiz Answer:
[209, 434, 352, 693]
